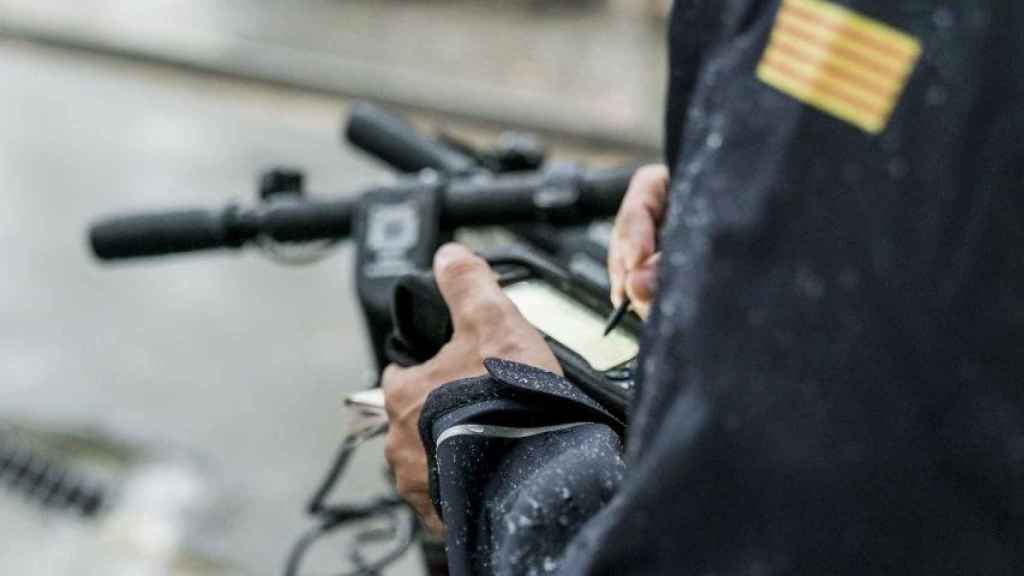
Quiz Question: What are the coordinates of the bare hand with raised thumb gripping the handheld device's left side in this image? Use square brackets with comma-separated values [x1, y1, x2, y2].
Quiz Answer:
[381, 244, 561, 533]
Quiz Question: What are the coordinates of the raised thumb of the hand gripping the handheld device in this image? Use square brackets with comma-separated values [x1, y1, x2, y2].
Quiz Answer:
[434, 244, 517, 332]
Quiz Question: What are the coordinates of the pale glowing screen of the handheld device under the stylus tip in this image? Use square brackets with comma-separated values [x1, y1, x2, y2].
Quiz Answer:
[505, 280, 640, 372]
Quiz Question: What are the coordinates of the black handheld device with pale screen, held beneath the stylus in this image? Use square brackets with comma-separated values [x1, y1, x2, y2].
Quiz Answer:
[387, 247, 640, 417]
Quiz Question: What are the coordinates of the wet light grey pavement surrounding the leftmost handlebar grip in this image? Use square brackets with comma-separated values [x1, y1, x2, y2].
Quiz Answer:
[0, 41, 416, 576]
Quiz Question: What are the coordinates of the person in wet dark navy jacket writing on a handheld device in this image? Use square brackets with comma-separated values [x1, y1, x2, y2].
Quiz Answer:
[384, 0, 1024, 574]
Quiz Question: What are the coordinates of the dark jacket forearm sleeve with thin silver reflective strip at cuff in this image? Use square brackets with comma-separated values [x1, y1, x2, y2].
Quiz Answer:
[420, 360, 624, 575]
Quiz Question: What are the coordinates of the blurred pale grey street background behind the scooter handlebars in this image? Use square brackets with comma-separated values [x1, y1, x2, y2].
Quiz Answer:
[0, 0, 669, 576]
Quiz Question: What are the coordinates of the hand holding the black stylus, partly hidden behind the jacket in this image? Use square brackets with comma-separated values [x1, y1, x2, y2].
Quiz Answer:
[608, 164, 669, 318]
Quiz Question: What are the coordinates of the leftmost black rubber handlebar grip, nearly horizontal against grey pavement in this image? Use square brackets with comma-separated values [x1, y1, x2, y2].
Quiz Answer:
[89, 210, 228, 260]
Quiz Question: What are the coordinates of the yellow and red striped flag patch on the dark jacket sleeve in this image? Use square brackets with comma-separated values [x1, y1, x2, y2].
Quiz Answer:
[757, 0, 921, 134]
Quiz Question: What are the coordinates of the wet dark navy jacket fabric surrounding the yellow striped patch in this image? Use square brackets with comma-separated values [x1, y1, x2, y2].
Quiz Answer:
[417, 0, 1024, 575]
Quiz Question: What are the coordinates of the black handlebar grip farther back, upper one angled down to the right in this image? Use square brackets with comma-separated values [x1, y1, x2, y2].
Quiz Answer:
[345, 102, 476, 175]
